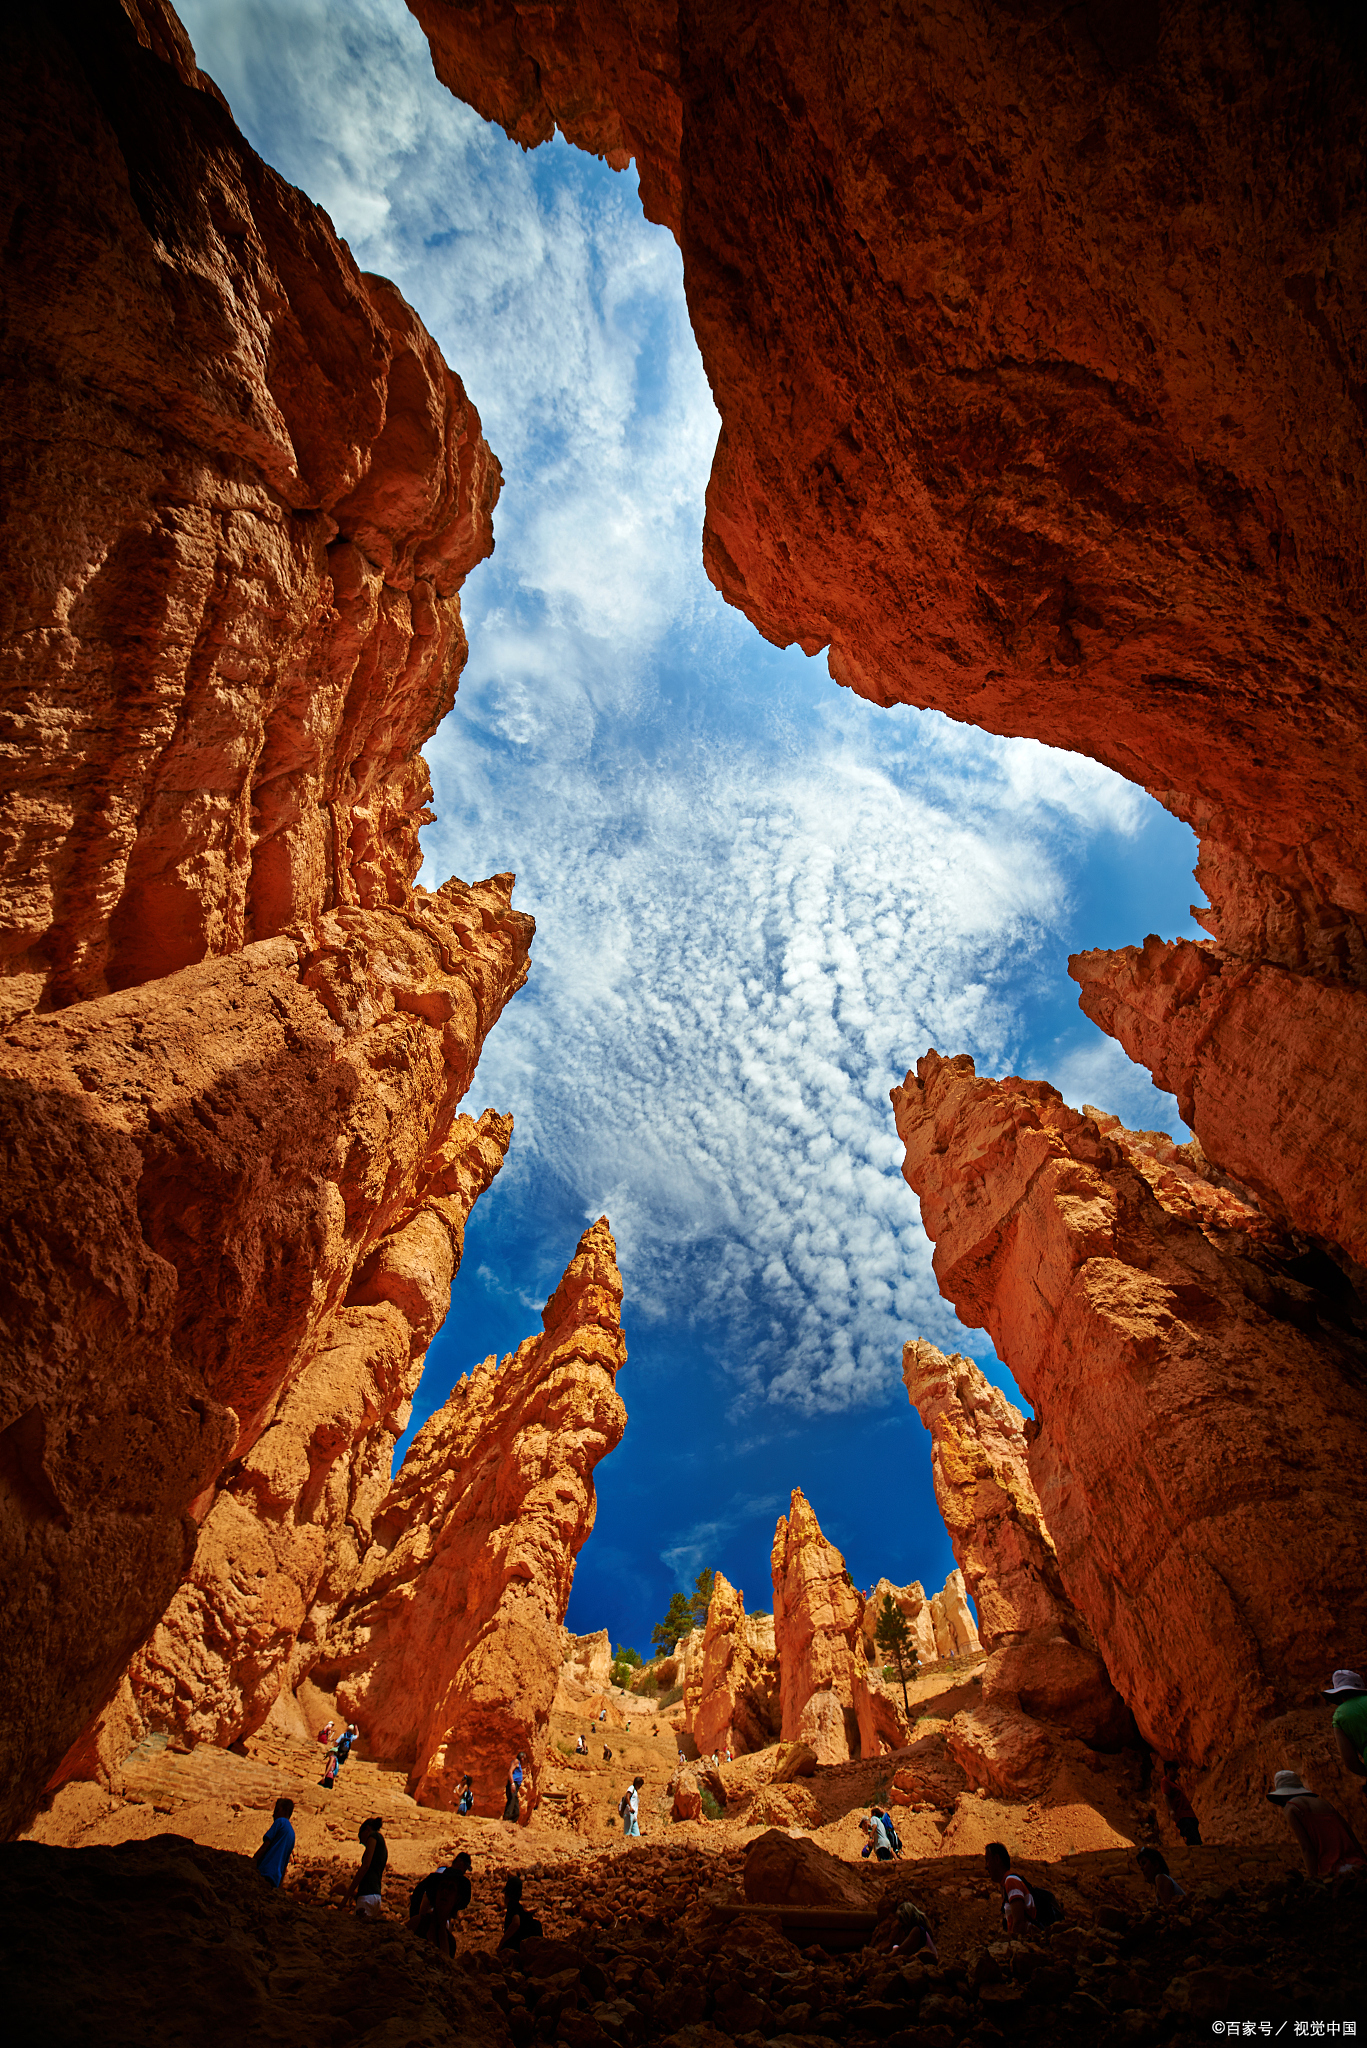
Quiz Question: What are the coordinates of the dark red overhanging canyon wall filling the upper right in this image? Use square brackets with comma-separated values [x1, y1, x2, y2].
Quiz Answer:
[420, 0, 1367, 1266]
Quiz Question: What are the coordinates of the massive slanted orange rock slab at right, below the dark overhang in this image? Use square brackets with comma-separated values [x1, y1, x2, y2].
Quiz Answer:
[894, 1053, 1367, 1763]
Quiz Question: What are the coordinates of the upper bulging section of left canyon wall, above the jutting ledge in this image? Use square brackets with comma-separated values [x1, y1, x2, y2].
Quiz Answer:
[0, 0, 498, 1014]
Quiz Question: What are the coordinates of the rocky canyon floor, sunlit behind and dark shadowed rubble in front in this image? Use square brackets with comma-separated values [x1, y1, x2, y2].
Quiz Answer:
[13, 1669, 1367, 2048]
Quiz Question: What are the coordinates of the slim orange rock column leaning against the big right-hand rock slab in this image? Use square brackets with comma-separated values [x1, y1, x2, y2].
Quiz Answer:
[902, 1341, 1131, 1747]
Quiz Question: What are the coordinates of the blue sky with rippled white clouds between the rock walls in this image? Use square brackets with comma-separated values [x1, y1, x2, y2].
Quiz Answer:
[180, 0, 1197, 1649]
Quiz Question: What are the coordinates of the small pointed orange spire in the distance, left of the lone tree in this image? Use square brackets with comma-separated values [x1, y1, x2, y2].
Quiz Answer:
[771, 1489, 906, 1763]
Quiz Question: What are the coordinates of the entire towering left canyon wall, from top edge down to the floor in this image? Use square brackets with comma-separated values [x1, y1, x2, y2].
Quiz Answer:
[0, 0, 533, 1833]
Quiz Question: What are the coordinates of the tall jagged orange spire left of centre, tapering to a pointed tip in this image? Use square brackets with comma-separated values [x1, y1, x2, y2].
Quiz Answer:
[314, 1219, 627, 1815]
